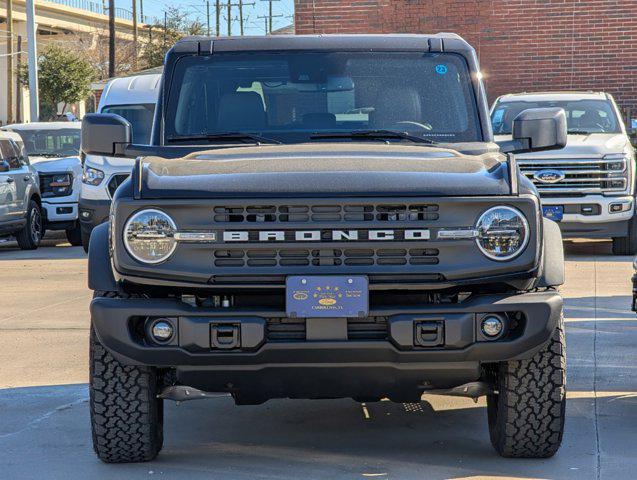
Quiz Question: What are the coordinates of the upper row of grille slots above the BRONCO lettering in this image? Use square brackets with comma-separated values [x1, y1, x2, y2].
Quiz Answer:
[214, 203, 438, 223]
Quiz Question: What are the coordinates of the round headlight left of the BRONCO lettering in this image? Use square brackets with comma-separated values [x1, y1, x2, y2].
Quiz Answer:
[124, 209, 177, 263]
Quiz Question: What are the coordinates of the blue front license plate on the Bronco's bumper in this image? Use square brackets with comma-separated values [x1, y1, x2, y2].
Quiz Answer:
[285, 275, 369, 318]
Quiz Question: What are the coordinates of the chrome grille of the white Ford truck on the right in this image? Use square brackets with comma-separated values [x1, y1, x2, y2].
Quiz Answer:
[517, 158, 627, 196]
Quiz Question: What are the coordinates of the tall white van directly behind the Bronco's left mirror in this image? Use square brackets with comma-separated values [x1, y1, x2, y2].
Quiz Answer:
[80, 74, 161, 252]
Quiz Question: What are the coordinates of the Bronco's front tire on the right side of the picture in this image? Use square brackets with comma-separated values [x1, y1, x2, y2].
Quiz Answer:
[487, 321, 566, 458]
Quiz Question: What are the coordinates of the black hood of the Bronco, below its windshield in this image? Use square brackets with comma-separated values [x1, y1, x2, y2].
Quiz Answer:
[135, 143, 511, 198]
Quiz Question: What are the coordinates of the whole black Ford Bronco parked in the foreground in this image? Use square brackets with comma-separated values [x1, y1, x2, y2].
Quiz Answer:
[82, 34, 566, 462]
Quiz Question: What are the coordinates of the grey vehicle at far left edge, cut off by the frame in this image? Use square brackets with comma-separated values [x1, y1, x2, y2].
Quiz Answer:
[0, 131, 43, 250]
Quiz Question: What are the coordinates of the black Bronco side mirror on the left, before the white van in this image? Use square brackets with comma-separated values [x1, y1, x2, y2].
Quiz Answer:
[82, 113, 133, 156]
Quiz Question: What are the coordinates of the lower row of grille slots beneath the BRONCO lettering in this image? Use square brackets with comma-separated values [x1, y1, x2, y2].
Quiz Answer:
[213, 248, 439, 268]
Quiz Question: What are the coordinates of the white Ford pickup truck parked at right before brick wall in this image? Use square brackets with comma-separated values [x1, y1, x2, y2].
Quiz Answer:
[491, 92, 637, 255]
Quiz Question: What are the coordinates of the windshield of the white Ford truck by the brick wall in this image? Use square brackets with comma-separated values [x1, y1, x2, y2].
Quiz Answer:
[491, 100, 621, 135]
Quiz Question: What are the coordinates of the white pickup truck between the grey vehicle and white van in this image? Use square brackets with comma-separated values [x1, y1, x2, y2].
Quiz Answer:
[2, 122, 82, 246]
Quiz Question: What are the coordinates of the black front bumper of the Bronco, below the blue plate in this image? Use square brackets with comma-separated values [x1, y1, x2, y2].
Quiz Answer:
[91, 291, 562, 401]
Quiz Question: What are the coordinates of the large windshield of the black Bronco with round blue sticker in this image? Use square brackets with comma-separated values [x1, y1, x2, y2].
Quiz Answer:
[164, 52, 482, 143]
